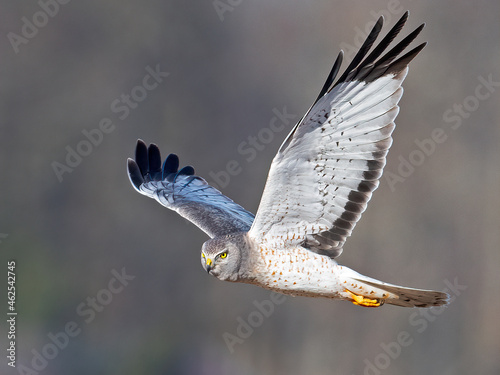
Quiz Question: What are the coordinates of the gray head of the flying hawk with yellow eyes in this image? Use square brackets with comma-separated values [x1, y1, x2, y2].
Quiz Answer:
[201, 236, 241, 281]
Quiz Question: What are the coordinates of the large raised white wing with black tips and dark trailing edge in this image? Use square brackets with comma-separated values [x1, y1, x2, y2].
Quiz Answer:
[249, 13, 426, 258]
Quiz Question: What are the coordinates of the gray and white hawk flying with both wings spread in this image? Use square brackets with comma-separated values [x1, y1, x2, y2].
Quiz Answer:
[127, 12, 449, 308]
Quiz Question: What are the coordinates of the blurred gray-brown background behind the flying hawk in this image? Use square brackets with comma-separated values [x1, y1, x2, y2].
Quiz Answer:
[0, 0, 500, 375]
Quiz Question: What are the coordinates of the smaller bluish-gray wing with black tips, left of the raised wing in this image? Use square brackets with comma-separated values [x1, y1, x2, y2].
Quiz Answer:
[127, 140, 254, 238]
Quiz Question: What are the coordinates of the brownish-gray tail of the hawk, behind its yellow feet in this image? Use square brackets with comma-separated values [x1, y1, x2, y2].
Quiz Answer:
[352, 278, 450, 307]
